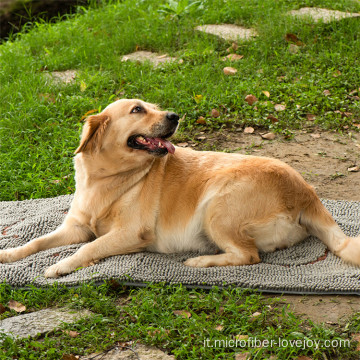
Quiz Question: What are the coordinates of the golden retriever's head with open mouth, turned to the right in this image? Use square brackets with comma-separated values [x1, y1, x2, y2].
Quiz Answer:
[75, 99, 179, 156]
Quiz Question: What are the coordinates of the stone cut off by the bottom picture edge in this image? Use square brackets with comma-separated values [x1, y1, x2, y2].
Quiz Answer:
[80, 344, 175, 360]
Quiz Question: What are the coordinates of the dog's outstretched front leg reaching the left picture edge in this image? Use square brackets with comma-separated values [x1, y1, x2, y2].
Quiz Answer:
[0, 217, 93, 263]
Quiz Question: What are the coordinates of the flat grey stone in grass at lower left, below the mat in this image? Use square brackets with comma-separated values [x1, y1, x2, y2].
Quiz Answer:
[0, 308, 92, 339]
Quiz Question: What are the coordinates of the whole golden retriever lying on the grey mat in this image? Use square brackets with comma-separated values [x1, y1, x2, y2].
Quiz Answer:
[0, 99, 360, 278]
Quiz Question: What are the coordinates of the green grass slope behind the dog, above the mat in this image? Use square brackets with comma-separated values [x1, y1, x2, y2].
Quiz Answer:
[0, 0, 360, 200]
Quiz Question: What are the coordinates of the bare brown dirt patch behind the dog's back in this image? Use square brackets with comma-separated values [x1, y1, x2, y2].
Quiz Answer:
[188, 130, 360, 201]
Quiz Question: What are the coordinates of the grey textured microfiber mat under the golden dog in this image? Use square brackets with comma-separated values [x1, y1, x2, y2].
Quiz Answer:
[0, 195, 360, 295]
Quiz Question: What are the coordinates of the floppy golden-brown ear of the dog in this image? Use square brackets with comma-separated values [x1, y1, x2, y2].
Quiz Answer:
[75, 114, 110, 154]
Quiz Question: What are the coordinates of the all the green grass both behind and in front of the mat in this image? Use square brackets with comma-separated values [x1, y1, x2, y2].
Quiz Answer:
[0, 0, 360, 359]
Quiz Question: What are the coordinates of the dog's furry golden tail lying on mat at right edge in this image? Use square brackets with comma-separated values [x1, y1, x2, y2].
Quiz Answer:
[300, 197, 360, 266]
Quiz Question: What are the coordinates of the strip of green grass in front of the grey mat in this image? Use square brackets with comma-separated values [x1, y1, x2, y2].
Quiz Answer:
[0, 281, 360, 360]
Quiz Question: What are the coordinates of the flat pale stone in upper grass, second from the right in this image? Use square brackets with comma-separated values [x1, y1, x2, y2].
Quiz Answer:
[195, 24, 257, 41]
